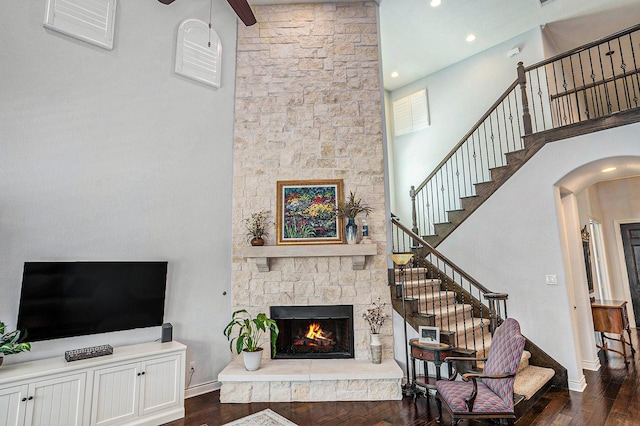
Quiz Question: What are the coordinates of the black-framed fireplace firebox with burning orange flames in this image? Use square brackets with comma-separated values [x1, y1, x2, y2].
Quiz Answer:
[270, 305, 354, 359]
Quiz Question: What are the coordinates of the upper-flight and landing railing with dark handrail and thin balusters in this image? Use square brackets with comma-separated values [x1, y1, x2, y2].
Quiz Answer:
[410, 24, 640, 240]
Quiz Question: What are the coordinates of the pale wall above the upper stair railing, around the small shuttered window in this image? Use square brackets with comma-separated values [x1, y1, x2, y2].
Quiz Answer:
[389, 28, 543, 223]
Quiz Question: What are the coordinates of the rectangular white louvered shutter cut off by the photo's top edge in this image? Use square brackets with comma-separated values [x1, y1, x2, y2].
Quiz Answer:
[44, 0, 116, 50]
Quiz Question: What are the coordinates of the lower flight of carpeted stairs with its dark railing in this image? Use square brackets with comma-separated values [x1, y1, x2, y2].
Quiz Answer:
[391, 219, 507, 353]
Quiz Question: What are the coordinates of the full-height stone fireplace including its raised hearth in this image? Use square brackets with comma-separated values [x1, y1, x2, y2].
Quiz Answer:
[218, 1, 402, 402]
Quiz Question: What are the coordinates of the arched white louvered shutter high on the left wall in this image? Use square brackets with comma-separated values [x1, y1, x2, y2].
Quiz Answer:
[175, 19, 222, 87]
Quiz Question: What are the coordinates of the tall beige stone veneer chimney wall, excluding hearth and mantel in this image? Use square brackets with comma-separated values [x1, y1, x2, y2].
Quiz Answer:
[232, 1, 393, 359]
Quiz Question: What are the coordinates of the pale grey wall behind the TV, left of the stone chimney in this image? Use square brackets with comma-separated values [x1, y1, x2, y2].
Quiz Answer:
[0, 0, 237, 392]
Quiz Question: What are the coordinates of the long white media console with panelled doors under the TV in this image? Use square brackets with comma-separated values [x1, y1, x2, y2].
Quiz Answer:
[0, 342, 187, 426]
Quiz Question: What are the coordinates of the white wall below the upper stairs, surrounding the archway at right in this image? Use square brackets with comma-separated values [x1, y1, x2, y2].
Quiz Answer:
[438, 124, 640, 390]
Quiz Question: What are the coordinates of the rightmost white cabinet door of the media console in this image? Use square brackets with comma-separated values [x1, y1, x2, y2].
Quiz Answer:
[140, 355, 182, 416]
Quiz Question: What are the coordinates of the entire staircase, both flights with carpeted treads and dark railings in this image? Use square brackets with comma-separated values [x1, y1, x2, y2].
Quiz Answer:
[389, 24, 640, 413]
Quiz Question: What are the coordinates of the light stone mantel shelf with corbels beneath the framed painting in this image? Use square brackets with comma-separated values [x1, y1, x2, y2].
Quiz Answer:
[241, 244, 378, 272]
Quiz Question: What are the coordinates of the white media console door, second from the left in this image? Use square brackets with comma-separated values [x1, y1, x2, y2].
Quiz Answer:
[25, 373, 86, 426]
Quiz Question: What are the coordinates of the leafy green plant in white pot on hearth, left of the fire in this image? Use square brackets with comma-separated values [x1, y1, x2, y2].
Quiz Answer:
[224, 309, 280, 371]
